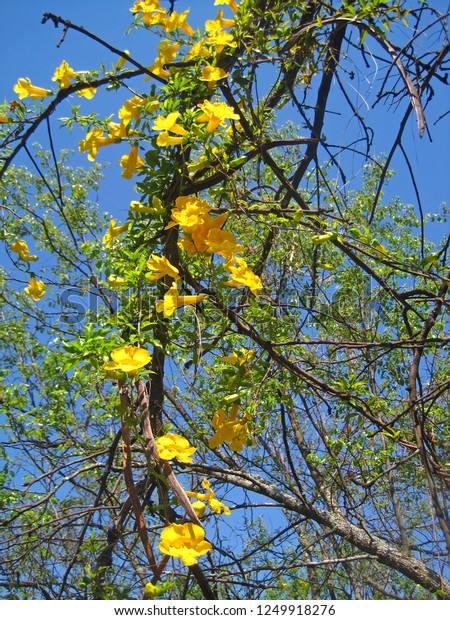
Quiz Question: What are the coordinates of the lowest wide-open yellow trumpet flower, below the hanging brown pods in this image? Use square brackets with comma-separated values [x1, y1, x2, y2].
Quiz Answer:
[158, 523, 212, 566]
